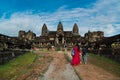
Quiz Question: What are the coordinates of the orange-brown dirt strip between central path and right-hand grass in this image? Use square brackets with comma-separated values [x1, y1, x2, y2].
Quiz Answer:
[67, 52, 120, 80]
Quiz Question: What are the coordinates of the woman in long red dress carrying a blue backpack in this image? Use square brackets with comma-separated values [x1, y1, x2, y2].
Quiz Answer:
[71, 43, 81, 66]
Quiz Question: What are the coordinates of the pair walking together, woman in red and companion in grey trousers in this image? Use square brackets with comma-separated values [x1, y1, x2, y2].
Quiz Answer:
[71, 44, 88, 66]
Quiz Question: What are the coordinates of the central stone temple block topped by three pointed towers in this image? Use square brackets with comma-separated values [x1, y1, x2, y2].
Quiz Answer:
[34, 22, 81, 47]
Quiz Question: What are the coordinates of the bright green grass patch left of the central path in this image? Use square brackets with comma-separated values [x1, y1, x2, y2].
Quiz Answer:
[0, 53, 35, 80]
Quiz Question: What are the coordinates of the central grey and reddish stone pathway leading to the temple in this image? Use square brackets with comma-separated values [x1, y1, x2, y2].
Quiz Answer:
[38, 53, 80, 80]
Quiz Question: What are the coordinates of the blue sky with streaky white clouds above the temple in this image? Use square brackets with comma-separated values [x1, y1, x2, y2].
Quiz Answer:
[0, 0, 120, 36]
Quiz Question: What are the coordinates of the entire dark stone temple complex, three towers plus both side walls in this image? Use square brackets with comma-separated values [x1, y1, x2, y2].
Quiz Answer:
[0, 22, 120, 64]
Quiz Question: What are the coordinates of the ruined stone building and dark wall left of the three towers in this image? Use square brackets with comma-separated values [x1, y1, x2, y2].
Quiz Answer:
[0, 31, 36, 50]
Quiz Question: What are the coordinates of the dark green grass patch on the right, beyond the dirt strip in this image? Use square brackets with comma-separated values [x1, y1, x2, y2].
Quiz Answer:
[88, 53, 120, 76]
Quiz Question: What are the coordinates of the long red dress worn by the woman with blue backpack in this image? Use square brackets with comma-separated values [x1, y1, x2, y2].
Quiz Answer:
[71, 46, 80, 65]
